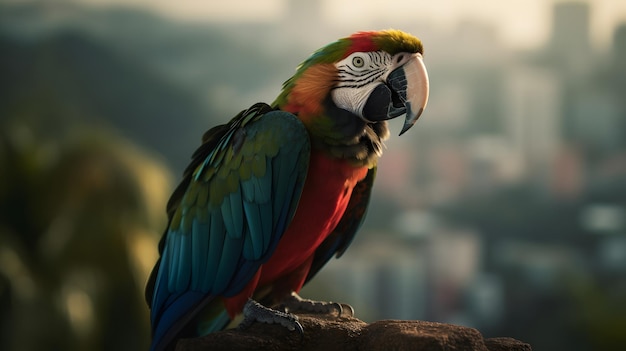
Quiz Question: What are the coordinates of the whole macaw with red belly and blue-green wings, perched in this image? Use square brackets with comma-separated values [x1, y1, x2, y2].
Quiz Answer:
[146, 30, 429, 350]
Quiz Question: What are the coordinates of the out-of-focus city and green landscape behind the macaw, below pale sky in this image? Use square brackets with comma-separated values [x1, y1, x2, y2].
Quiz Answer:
[0, 1, 626, 350]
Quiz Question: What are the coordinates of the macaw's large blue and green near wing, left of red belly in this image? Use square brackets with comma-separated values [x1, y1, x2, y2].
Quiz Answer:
[146, 104, 310, 350]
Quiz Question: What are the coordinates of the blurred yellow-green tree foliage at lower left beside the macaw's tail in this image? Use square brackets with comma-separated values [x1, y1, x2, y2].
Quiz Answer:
[0, 125, 171, 350]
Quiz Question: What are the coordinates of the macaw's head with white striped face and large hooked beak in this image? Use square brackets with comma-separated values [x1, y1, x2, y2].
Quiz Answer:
[274, 30, 428, 139]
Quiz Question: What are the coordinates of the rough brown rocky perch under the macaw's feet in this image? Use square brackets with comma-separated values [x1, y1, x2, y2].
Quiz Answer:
[176, 314, 531, 351]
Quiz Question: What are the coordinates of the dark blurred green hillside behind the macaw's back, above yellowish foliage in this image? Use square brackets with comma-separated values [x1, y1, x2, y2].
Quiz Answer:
[0, 30, 208, 173]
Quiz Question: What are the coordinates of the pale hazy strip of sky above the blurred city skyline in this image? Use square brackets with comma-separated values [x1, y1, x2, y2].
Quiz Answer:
[74, 0, 626, 48]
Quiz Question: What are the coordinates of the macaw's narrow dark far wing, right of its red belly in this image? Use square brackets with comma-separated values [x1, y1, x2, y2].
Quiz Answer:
[305, 167, 376, 284]
